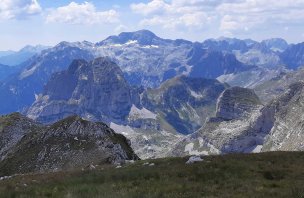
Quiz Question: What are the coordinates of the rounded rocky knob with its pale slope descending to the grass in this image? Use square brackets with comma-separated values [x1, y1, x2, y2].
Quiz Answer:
[171, 87, 267, 156]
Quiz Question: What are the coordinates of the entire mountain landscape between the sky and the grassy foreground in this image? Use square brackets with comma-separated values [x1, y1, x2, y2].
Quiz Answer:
[0, 30, 304, 170]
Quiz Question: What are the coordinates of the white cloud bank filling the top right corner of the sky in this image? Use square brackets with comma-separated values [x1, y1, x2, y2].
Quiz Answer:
[216, 0, 304, 31]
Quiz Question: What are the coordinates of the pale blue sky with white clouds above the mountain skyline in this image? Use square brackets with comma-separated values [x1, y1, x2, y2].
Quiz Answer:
[0, 0, 304, 51]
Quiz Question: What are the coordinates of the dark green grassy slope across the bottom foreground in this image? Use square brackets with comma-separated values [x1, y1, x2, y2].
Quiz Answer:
[0, 152, 304, 198]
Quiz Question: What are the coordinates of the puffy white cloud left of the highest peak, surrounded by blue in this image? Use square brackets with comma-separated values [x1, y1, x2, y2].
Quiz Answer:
[46, 2, 119, 25]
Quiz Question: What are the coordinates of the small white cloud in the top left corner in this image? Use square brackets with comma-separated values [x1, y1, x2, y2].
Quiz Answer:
[0, 0, 41, 20]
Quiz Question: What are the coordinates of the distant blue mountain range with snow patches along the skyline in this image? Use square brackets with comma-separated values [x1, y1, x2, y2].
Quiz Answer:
[0, 30, 302, 113]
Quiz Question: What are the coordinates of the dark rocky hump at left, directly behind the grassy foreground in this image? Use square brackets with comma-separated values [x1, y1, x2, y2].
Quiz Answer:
[0, 114, 139, 175]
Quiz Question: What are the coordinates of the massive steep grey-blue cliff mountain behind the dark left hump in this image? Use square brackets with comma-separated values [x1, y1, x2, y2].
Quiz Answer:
[27, 58, 133, 123]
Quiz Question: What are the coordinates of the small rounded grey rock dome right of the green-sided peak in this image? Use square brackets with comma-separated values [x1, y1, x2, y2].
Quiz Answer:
[216, 87, 261, 120]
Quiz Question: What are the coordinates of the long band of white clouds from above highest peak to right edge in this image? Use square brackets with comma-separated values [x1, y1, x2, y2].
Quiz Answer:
[131, 0, 304, 33]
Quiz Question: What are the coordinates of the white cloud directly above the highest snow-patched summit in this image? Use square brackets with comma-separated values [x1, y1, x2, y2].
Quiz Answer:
[131, 0, 214, 29]
